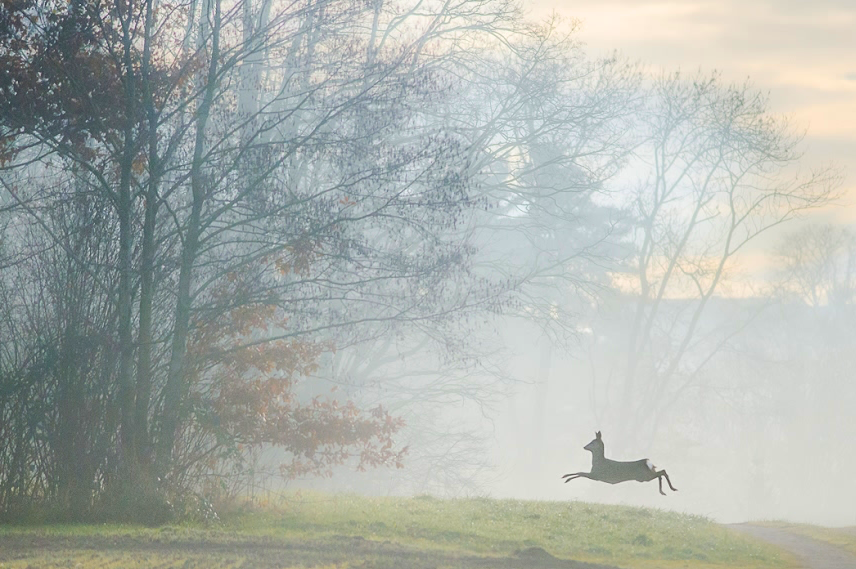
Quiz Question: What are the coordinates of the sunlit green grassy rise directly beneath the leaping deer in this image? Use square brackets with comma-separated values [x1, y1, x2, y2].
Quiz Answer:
[231, 494, 792, 568]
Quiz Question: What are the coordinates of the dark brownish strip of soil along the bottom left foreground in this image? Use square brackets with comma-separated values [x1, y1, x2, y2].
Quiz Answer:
[0, 533, 617, 569]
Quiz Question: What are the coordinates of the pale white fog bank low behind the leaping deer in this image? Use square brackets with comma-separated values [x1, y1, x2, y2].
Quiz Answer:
[298, 282, 856, 526]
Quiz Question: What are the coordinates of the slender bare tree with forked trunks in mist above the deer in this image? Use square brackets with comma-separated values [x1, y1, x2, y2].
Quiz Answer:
[588, 73, 840, 439]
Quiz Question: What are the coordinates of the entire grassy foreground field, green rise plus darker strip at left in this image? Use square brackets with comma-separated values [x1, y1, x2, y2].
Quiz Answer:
[0, 494, 794, 569]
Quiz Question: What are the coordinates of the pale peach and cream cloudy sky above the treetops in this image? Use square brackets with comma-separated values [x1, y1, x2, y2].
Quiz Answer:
[524, 0, 856, 223]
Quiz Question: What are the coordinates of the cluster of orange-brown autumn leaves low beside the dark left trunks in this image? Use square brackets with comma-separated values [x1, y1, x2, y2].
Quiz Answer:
[188, 253, 407, 478]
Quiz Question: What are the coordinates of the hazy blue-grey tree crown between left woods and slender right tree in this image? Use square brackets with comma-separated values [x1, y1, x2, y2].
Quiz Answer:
[445, 19, 640, 339]
